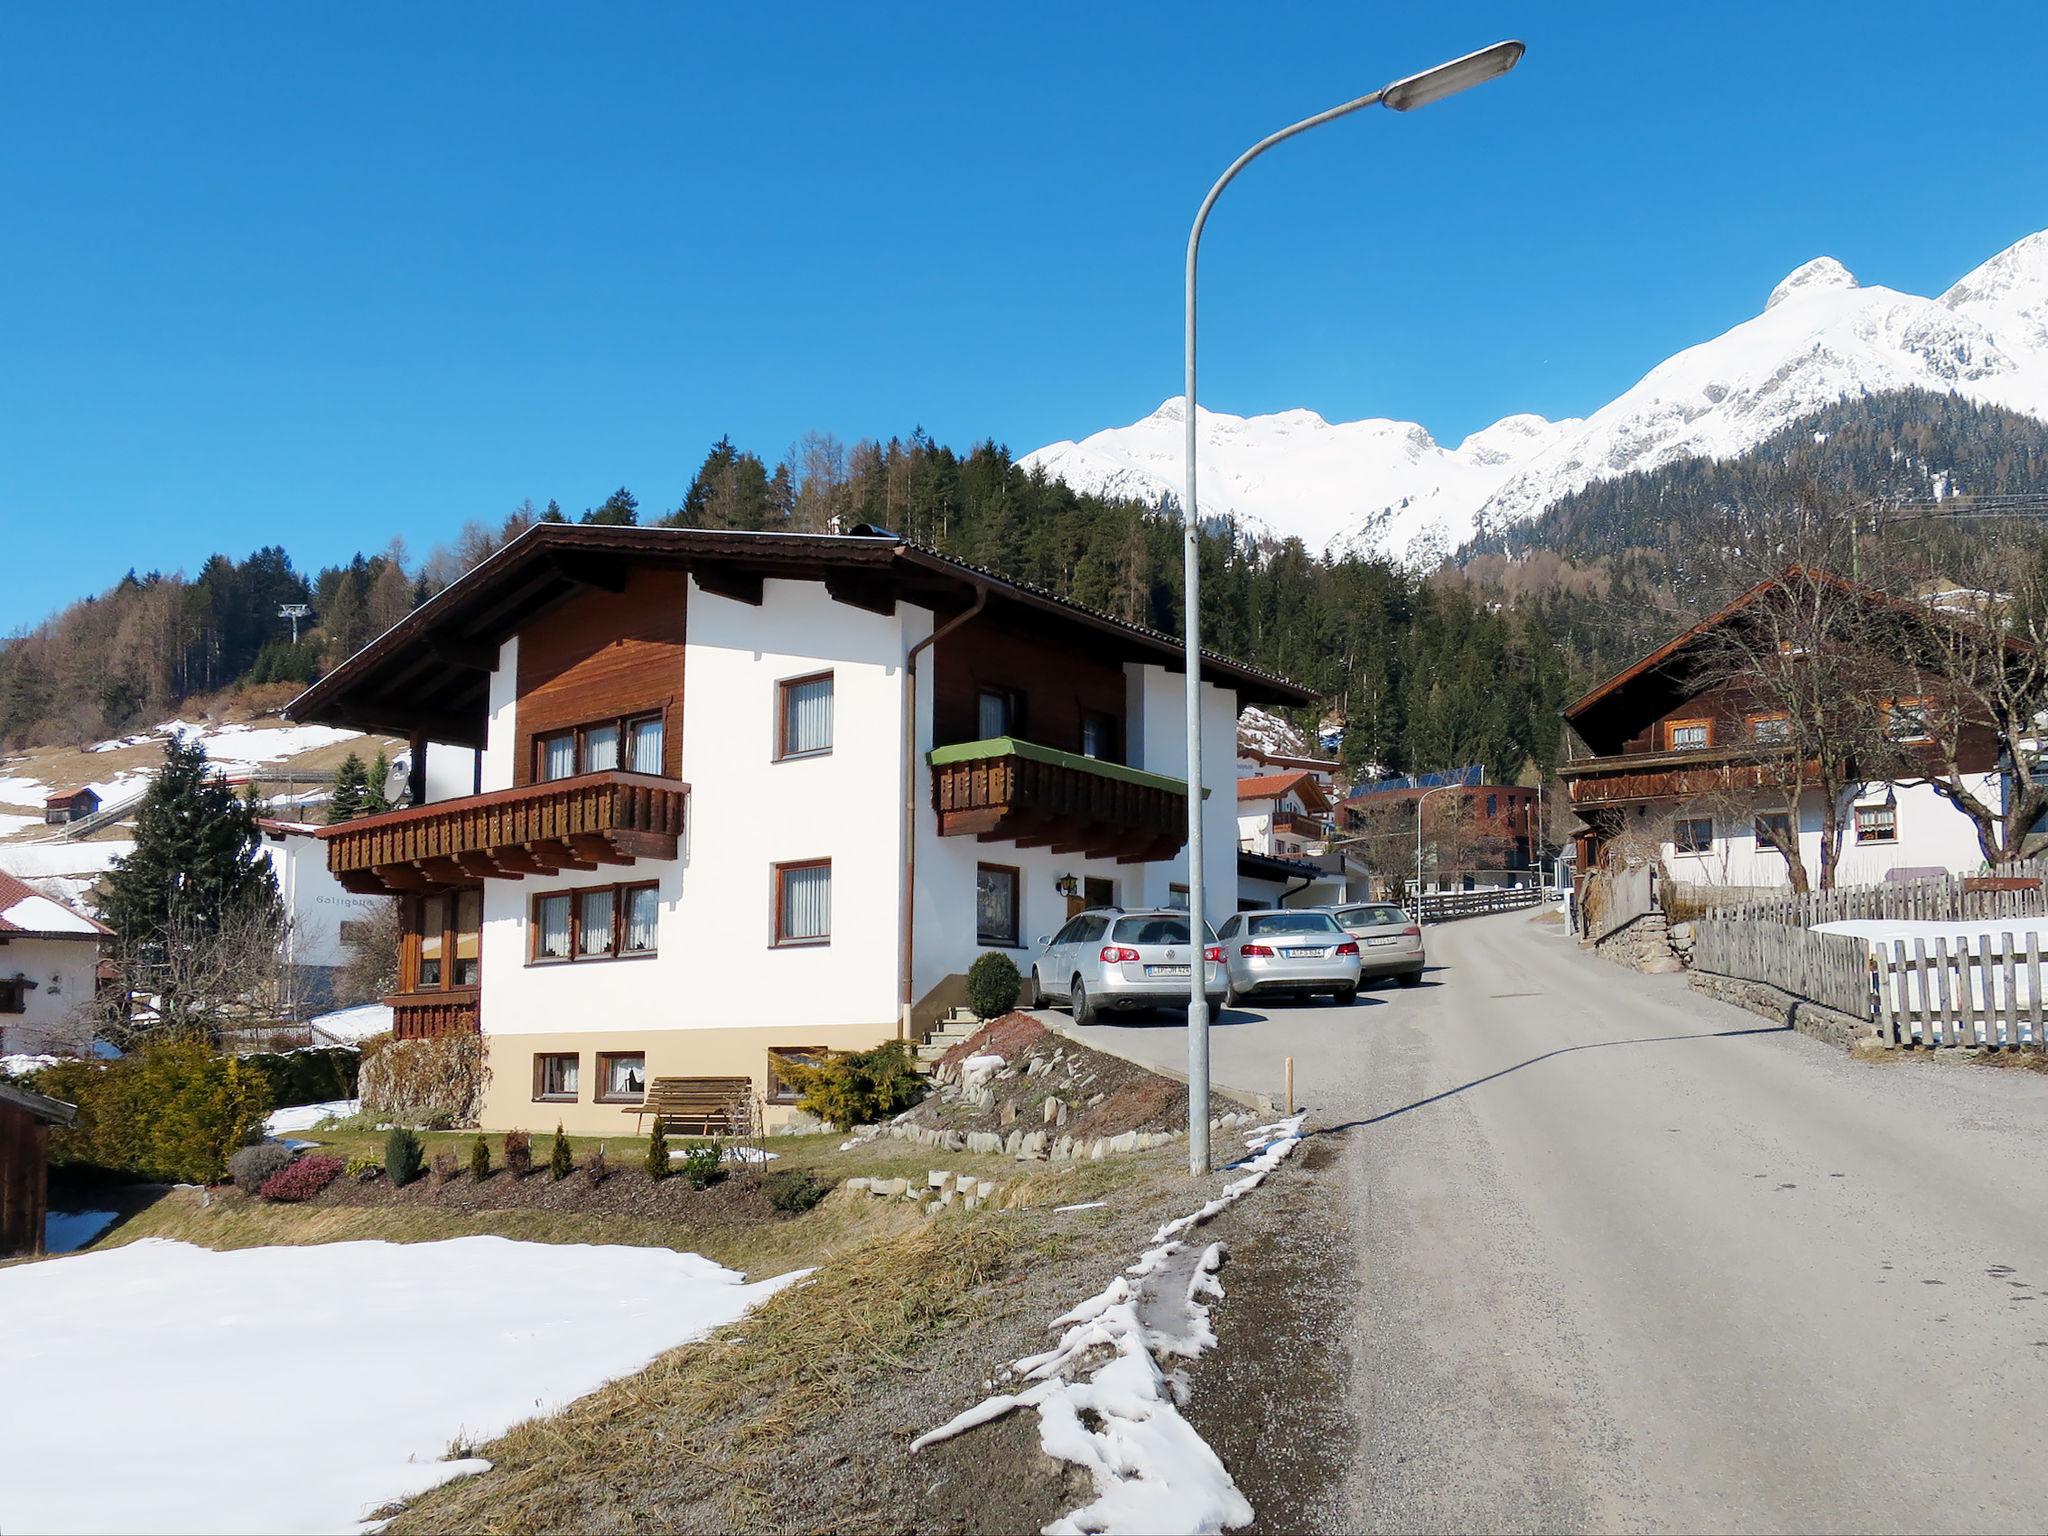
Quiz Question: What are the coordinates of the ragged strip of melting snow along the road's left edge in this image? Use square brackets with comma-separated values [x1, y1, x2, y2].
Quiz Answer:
[909, 1114, 1307, 1536]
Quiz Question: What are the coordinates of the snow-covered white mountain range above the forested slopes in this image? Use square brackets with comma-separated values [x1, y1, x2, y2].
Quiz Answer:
[1022, 231, 2048, 565]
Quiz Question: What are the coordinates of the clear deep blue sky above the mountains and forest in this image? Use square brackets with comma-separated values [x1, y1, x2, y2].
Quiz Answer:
[0, 0, 2048, 633]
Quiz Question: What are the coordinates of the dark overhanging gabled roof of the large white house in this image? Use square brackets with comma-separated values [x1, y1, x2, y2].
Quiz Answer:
[285, 522, 1317, 745]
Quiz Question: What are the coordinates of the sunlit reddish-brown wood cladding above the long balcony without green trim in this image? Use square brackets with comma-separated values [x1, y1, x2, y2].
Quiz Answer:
[512, 567, 690, 784]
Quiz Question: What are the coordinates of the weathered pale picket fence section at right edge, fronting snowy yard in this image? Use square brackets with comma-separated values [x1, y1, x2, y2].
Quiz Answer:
[1875, 932, 2044, 1051]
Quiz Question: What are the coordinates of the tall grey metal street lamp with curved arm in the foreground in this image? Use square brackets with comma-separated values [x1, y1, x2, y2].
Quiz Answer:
[1182, 43, 1522, 1174]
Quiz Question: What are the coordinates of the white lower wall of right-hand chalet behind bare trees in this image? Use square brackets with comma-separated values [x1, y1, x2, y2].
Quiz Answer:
[1651, 774, 1999, 885]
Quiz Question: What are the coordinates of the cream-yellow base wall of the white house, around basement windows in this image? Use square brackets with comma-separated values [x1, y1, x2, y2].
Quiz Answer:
[481, 1020, 897, 1137]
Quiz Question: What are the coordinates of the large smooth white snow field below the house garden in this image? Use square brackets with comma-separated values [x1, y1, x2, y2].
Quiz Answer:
[0, 1237, 803, 1532]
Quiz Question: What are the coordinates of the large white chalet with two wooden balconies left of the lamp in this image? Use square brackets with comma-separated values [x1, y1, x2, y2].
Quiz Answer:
[291, 524, 1313, 1133]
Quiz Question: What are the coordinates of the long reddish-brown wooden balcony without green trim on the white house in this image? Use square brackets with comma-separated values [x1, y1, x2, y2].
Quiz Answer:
[319, 772, 690, 895]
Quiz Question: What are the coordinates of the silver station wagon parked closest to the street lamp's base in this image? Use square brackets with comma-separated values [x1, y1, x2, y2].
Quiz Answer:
[1030, 907, 1225, 1024]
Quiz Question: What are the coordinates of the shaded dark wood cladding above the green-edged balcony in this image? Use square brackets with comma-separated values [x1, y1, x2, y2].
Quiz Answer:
[932, 616, 1130, 762]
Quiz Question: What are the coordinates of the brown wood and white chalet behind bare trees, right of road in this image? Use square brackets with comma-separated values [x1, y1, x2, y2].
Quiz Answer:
[1559, 567, 2003, 887]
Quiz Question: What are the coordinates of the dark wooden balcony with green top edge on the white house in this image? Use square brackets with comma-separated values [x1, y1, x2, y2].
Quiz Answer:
[930, 735, 1188, 864]
